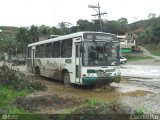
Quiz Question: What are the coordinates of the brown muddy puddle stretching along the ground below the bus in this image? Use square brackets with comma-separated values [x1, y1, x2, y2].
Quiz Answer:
[31, 77, 151, 102]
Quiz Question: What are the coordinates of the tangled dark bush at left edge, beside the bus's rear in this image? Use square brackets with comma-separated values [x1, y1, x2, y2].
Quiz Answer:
[0, 63, 46, 92]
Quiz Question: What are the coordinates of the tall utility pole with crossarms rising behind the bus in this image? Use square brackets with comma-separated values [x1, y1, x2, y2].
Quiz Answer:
[88, 3, 107, 32]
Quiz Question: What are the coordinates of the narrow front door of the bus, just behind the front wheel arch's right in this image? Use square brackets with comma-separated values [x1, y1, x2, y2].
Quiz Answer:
[75, 43, 81, 83]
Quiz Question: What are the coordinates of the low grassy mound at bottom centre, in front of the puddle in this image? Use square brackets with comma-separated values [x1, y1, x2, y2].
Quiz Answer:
[53, 98, 131, 120]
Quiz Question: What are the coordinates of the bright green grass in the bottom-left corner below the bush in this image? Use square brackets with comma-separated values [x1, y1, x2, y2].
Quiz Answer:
[0, 85, 48, 120]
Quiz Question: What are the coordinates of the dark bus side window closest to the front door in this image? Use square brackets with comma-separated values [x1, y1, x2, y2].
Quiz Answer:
[61, 39, 72, 58]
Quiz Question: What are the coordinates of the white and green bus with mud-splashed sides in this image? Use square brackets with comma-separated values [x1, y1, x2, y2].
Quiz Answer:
[27, 32, 121, 86]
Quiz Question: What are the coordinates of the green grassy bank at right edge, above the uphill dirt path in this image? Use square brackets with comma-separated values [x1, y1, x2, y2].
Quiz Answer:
[143, 44, 160, 56]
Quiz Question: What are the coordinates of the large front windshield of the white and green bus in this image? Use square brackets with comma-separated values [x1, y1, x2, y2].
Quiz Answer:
[82, 41, 119, 66]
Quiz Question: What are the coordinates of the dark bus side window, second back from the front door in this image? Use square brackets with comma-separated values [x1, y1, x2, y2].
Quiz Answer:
[52, 41, 60, 58]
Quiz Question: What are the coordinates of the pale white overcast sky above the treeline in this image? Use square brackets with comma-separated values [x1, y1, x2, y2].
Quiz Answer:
[0, 0, 160, 27]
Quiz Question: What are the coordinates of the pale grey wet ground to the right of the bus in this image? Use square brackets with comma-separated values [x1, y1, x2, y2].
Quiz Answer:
[118, 59, 160, 114]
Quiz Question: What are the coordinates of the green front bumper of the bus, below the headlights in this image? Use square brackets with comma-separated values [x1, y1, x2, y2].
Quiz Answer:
[82, 76, 121, 85]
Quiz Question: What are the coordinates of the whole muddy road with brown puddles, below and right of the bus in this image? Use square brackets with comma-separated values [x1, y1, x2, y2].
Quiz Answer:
[0, 59, 160, 114]
